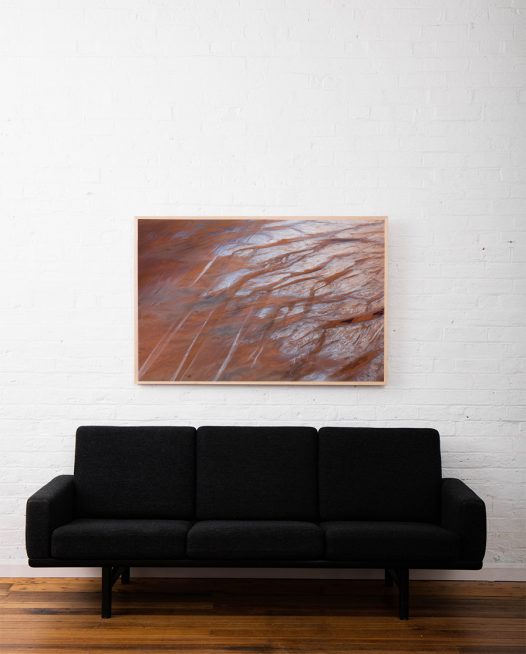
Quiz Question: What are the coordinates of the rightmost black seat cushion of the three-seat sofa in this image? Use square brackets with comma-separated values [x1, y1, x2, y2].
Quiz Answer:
[322, 521, 459, 565]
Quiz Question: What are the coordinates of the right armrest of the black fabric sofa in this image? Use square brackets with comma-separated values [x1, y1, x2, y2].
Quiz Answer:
[442, 479, 486, 562]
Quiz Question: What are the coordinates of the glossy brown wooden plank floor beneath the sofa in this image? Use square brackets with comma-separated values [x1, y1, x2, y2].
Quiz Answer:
[0, 570, 526, 654]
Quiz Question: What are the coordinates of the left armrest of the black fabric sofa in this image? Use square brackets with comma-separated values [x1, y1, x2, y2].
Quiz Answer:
[26, 475, 75, 559]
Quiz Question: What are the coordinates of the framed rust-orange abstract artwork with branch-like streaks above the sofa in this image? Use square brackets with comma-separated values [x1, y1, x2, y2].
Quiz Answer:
[136, 217, 386, 384]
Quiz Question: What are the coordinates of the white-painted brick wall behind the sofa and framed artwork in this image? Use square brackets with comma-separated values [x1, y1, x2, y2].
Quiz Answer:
[0, 0, 526, 578]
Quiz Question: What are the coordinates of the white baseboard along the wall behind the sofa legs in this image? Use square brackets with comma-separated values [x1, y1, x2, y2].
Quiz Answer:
[0, 561, 526, 581]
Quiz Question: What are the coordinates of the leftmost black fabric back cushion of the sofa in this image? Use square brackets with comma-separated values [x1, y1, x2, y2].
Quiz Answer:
[75, 427, 195, 518]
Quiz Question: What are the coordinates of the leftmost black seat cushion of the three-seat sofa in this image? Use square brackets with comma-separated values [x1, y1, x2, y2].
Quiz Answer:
[51, 518, 190, 559]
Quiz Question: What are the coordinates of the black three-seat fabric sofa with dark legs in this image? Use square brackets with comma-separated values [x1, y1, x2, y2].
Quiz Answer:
[26, 427, 486, 619]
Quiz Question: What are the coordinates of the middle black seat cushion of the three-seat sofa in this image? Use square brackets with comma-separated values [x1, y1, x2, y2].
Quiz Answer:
[187, 520, 323, 560]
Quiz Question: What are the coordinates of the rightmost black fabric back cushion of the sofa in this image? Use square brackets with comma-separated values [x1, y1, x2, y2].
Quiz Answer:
[319, 427, 442, 523]
